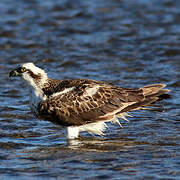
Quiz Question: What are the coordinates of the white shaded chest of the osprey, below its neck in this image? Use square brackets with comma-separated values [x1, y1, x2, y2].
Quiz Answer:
[29, 91, 46, 115]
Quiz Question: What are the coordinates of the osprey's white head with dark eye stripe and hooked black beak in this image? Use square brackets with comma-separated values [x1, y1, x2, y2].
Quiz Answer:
[9, 63, 48, 87]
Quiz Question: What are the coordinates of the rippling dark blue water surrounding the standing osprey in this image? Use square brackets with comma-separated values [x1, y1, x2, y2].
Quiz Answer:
[0, 0, 180, 180]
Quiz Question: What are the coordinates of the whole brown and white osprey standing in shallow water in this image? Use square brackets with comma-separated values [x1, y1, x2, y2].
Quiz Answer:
[9, 63, 169, 139]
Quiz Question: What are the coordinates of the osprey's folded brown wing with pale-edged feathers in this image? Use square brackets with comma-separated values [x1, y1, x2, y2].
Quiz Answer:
[38, 80, 169, 126]
